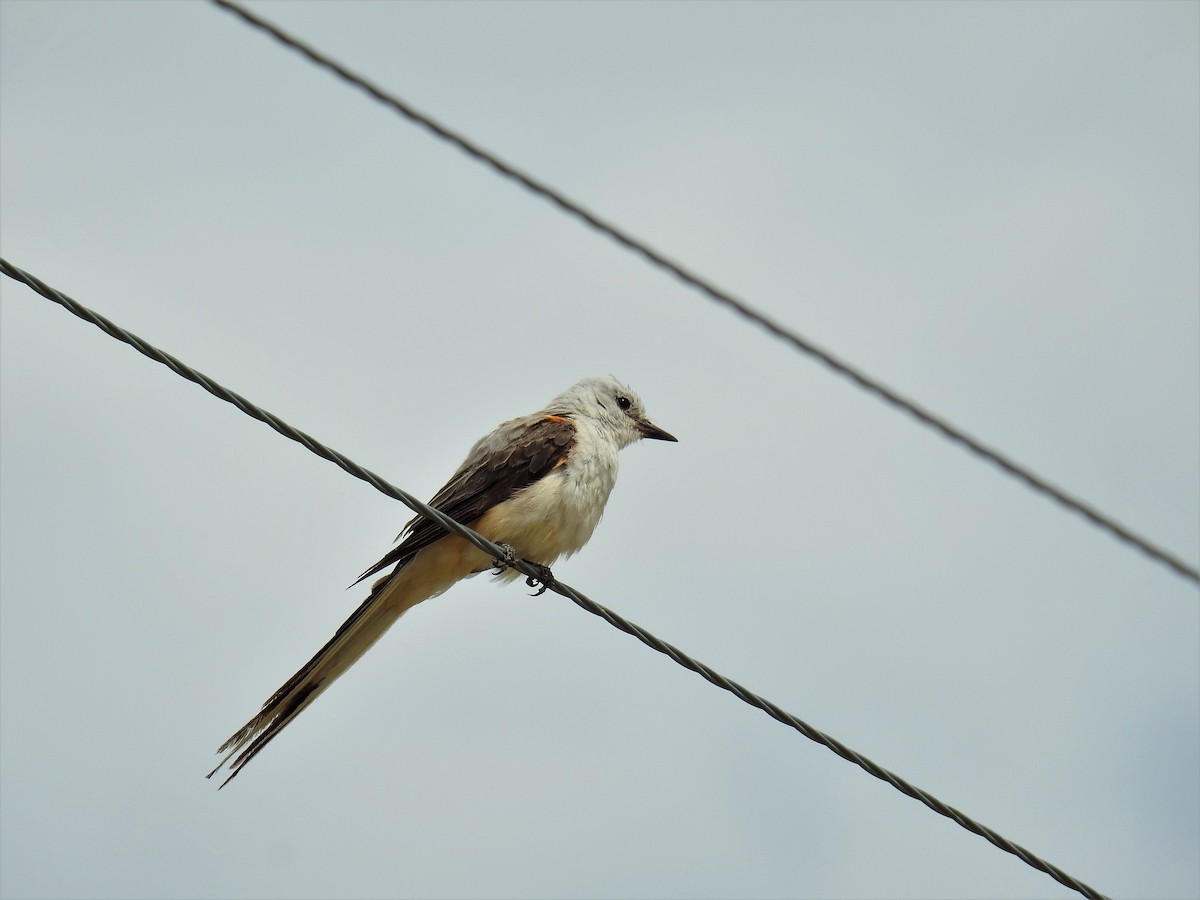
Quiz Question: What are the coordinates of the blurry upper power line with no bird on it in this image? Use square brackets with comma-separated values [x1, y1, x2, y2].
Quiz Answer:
[212, 0, 1200, 584]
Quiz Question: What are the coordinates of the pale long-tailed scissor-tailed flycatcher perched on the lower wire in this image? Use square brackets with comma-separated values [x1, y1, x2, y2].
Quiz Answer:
[209, 378, 676, 787]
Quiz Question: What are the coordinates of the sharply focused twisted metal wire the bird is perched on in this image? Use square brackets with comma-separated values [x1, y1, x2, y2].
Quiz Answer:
[0, 258, 1108, 900]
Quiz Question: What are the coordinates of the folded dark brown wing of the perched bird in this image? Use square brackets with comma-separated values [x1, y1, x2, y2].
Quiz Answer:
[354, 415, 575, 584]
